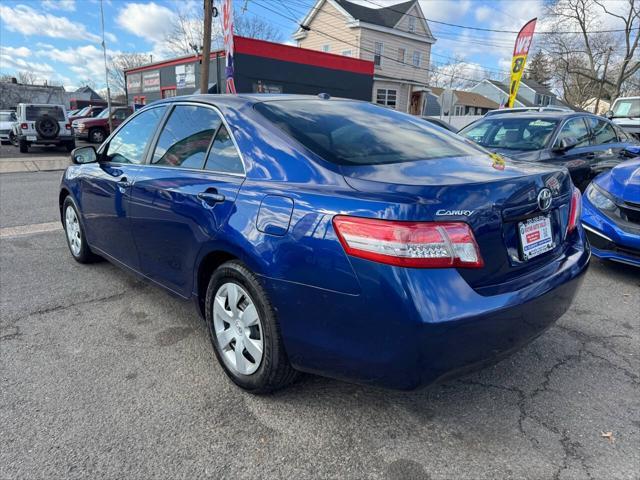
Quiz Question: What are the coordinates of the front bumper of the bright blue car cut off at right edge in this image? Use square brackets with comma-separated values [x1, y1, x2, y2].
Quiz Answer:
[582, 196, 640, 267]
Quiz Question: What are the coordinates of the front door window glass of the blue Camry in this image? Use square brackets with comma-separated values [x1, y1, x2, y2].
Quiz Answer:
[105, 105, 166, 164]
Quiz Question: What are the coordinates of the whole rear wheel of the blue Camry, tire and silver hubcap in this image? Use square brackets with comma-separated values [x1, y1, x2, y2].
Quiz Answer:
[205, 261, 297, 393]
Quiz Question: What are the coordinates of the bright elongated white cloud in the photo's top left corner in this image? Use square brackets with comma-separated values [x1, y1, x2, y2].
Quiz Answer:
[0, 5, 101, 42]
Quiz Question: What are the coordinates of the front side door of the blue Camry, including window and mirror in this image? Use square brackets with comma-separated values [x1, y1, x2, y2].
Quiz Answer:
[81, 106, 166, 270]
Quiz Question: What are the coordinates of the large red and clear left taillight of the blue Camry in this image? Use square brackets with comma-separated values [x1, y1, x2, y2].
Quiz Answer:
[333, 215, 484, 268]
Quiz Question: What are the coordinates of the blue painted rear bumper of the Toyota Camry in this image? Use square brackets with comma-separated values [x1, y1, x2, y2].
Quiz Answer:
[263, 229, 590, 389]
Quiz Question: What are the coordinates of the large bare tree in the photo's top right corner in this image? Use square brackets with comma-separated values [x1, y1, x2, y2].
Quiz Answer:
[542, 0, 640, 106]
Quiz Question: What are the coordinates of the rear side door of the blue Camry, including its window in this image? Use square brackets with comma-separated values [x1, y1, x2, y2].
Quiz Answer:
[131, 103, 244, 297]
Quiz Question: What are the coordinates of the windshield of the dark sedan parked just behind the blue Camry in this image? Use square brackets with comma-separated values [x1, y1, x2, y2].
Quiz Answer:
[459, 116, 558, 151]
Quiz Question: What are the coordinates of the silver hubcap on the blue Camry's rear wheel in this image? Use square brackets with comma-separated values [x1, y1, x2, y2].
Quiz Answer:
[213, 282, 264, 375]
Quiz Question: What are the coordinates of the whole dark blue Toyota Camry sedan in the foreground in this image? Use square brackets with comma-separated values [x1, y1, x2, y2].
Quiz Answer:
[59, 95, 590, 392]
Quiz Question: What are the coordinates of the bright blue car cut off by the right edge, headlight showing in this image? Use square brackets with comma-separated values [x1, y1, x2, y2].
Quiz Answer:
[582, 158, 640, 267]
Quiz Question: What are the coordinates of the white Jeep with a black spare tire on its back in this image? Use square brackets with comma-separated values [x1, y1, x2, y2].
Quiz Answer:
[13, 103, 76, 153]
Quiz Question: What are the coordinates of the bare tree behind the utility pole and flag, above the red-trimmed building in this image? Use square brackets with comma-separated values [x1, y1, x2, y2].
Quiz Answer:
[165, 10, 282, 55]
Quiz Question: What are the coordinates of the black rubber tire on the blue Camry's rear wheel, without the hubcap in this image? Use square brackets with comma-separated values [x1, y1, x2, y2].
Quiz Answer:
[205, 260, 298, 393]
